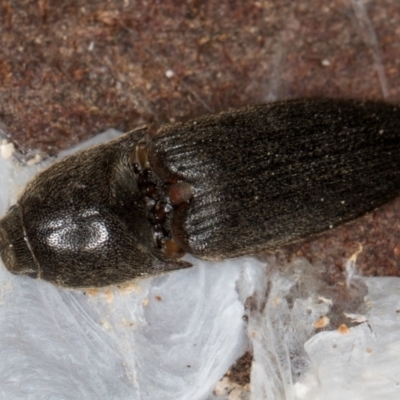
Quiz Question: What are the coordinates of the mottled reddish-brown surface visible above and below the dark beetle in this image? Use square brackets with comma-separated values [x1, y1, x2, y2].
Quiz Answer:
[0, 0, 400, 276]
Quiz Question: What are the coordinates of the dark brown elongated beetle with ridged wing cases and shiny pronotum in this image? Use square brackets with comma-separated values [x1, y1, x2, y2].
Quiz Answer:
[0, 100, 400, 287]
